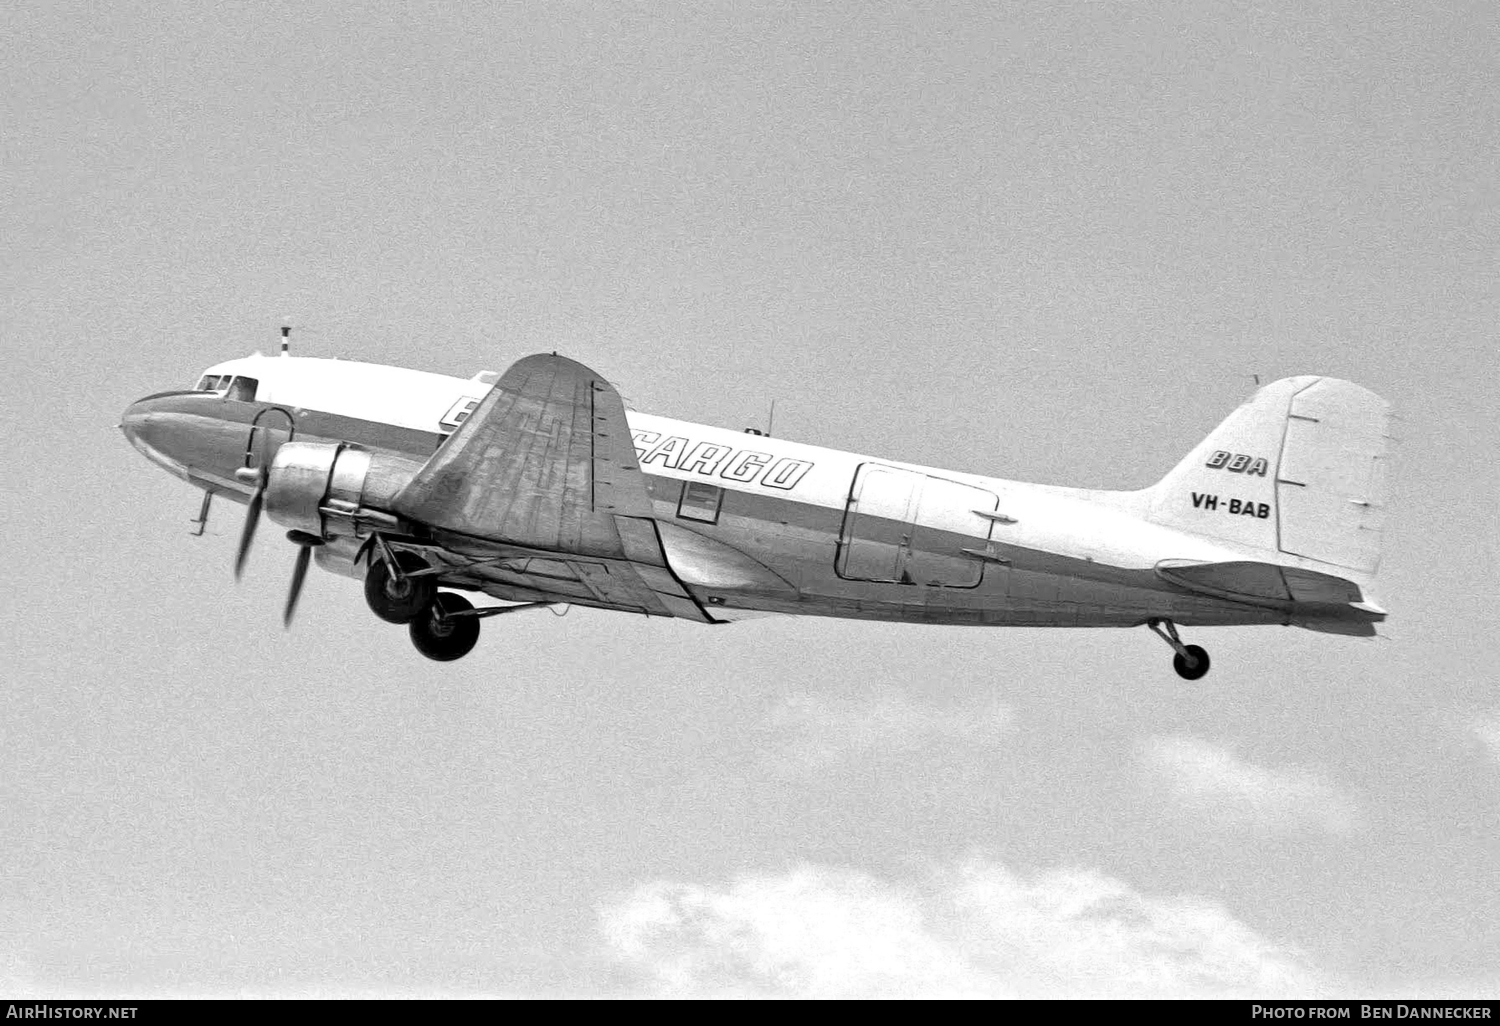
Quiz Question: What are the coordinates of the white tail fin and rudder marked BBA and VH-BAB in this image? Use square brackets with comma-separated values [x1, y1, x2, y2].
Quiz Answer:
[1148, 377, 1391, 578]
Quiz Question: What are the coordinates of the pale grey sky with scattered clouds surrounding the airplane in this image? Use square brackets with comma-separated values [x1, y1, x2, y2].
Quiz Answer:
[0, 0, 1500, 998]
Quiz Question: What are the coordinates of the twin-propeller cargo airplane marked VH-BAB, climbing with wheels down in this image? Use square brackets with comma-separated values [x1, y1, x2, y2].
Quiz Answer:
[120, 336, 1391, 681]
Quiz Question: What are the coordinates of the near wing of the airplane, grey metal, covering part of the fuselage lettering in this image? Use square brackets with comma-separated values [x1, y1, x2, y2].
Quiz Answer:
[393, 354, 713, 623]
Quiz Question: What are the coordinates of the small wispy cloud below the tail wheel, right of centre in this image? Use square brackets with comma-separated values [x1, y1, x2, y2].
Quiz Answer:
[1142, 737, 1364, 834]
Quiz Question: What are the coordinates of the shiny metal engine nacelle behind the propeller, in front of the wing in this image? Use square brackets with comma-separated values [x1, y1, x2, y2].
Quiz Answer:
[266, 441, 422, 542]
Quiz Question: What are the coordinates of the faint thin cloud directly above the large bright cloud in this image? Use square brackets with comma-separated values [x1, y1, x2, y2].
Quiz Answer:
[770, 692, 1011, 765]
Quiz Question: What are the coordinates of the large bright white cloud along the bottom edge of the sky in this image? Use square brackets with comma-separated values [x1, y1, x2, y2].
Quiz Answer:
[602, 860, 1323, 998]
